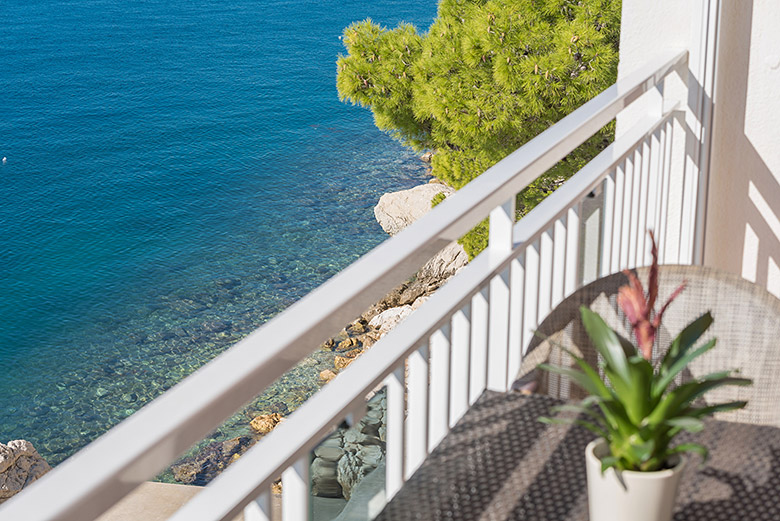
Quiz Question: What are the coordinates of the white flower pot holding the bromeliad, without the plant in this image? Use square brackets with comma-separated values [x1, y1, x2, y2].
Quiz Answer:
[585, 438, 685, 521]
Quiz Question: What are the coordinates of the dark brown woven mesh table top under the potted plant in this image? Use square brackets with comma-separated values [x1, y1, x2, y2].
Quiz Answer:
[377, 392, 780, 521]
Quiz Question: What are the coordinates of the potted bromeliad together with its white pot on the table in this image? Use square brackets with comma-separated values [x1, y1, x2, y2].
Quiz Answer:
[540, 232, 752, 521]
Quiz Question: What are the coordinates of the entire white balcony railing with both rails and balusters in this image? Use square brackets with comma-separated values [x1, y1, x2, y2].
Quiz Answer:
[0, 52, 697, 521]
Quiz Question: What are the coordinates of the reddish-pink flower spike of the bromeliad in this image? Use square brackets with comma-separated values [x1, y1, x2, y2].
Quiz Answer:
[617, 230, 686, 360]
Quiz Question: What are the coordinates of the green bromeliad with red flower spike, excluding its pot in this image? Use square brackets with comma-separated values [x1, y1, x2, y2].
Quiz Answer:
[540, 232, 752, 472]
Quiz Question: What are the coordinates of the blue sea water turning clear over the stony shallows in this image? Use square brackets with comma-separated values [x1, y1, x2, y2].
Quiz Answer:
[0, 0, 436, 463]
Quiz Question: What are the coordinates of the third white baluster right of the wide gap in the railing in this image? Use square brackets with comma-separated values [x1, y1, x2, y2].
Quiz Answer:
[428, 324, 450, 452]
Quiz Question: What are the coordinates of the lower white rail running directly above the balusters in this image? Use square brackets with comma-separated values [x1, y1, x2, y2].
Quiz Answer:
[170, 105, 674, 521]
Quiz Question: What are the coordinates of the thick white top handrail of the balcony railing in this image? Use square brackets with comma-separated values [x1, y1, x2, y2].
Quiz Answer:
[0, 51, 687, 521]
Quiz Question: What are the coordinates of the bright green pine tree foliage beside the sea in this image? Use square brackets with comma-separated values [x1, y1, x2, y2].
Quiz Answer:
[337, 0, 620, 254]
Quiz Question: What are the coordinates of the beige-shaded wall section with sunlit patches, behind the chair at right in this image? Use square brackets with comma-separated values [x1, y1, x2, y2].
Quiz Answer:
[705, 0, 780, 296]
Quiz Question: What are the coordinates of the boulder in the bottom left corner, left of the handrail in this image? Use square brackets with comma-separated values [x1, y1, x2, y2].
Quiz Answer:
[0, 440, 51, 503]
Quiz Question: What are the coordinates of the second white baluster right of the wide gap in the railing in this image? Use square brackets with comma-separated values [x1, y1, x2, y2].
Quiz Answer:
[404, 345, 428, 480]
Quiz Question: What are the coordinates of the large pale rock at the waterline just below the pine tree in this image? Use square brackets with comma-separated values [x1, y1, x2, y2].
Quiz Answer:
[374, 183, 455, 235]
